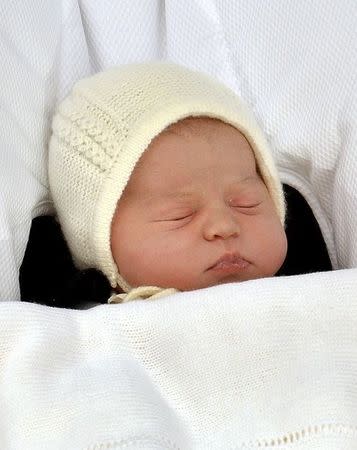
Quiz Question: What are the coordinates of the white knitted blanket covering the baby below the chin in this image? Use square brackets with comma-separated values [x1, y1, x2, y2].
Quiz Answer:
[0, 269, 357, 450]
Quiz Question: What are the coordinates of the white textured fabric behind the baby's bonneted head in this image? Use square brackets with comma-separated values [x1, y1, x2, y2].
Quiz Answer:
[0, 0, 357, 300]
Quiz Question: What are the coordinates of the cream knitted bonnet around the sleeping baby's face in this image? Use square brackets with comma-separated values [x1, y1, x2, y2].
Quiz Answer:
[49, 62, 285, 292]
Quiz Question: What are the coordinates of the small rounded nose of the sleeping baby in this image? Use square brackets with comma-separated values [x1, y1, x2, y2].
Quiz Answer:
[203, 207, 240, 241]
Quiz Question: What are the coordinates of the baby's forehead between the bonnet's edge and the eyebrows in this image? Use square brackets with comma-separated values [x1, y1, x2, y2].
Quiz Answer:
[129, 117, 256, 191]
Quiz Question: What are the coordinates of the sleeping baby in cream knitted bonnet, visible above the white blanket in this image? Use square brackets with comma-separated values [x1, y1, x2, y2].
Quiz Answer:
[49, 63, 287, 302]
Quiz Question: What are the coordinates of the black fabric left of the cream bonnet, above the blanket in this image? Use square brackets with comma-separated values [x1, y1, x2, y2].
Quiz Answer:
[20, 216, 111, 308]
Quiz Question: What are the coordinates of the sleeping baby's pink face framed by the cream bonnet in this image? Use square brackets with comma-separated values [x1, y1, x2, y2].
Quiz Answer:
[111, 118, 287, 290]
